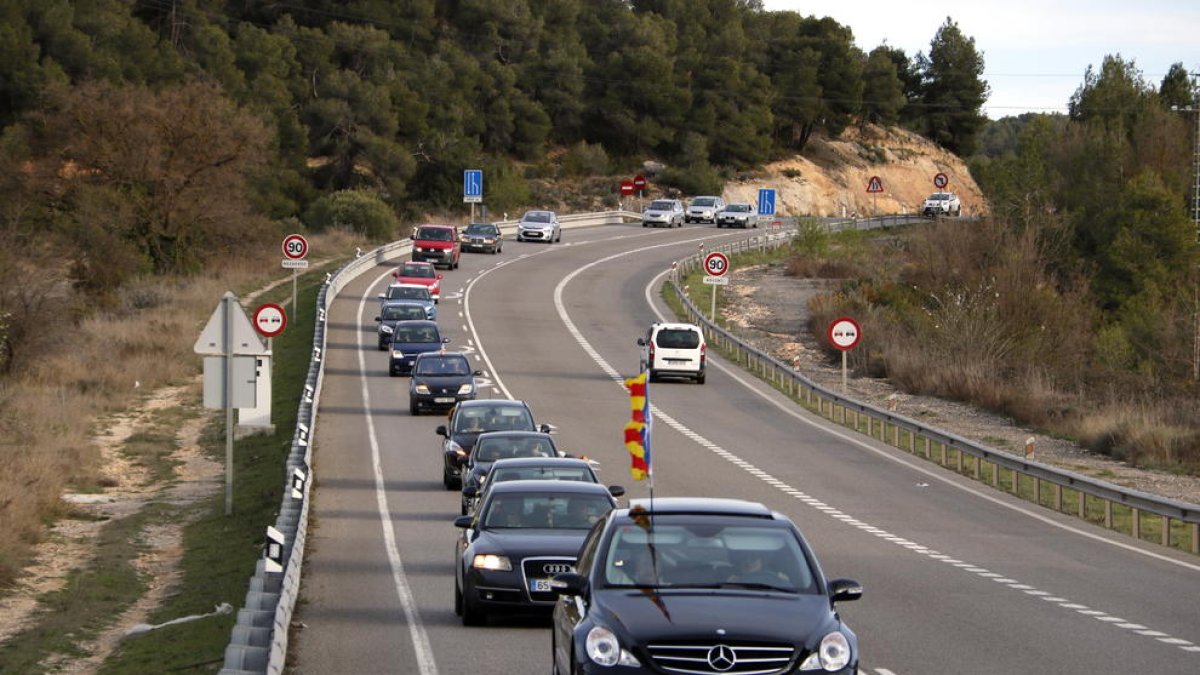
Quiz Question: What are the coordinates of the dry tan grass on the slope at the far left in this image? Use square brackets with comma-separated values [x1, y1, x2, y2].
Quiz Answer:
[0, 232, 367, 587]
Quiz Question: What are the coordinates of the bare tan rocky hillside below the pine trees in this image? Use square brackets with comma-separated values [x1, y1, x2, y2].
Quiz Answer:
[724, 120, 986, 216]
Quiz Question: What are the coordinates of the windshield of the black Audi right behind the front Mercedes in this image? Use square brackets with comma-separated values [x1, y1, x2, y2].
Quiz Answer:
[480, 492, 612, 530]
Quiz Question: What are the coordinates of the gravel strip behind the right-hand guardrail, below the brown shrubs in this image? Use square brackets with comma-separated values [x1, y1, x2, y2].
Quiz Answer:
[722, 263, 1200, 504]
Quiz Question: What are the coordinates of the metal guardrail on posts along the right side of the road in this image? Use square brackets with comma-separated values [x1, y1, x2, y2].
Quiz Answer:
[668, 224, 1200, 554]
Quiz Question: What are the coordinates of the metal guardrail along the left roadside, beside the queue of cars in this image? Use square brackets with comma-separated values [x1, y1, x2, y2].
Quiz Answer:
[221, 211, 641, 675]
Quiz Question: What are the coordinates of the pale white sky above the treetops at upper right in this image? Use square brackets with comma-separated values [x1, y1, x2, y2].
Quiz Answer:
[763, 0, 1200, 119]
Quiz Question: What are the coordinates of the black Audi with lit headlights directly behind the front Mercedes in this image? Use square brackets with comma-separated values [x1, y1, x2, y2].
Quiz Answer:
[454, 480, 617, 626]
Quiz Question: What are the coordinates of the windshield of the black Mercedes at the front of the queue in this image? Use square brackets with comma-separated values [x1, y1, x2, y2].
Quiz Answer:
[602, 515, 816, 593]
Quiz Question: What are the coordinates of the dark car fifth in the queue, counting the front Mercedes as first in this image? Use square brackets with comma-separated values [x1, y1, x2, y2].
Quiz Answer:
[436, 399, 553, 490]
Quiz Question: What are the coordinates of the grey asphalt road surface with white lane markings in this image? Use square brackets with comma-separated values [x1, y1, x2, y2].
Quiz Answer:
[289, 225, 1200, 675]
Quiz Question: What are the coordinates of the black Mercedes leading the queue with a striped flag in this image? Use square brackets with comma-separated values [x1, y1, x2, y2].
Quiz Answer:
[544, 497, 863, 675]
